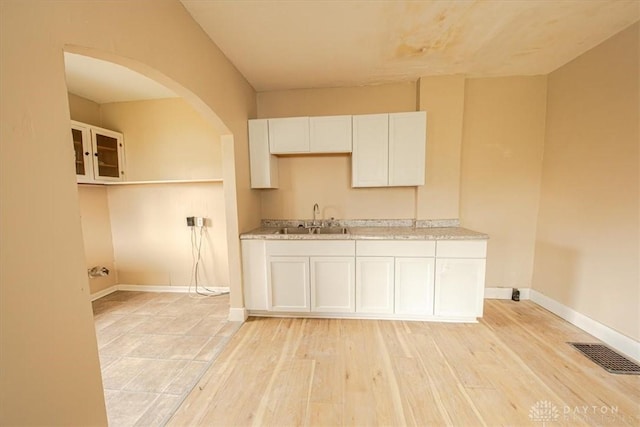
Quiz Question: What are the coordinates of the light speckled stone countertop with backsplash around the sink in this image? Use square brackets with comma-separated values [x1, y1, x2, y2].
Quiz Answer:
[240, 220, 489, 240]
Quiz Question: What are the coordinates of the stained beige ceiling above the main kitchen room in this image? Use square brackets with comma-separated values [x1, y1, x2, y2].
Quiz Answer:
[181, 0, 640, 92]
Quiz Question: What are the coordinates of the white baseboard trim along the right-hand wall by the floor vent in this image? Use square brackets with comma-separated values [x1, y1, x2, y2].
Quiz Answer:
[531, 289, 640, 361]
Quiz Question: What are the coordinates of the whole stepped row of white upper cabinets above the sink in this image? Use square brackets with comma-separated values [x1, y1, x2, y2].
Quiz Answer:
[249, 111, 427, 188]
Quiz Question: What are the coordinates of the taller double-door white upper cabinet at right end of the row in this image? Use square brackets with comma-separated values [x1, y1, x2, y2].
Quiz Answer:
[352, 111, 427, 187]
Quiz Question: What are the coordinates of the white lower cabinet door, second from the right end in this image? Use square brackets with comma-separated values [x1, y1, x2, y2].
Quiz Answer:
[395, 258, 435, 315]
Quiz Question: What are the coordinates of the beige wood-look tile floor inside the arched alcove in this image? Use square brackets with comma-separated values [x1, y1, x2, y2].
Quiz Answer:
[93, 291, 240, 427]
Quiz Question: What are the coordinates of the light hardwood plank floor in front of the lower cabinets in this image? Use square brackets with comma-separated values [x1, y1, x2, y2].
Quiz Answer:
[169, 300, 640, 426]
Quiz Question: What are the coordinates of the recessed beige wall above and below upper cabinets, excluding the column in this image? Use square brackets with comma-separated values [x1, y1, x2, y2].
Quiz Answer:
[257, 83, 416, 219]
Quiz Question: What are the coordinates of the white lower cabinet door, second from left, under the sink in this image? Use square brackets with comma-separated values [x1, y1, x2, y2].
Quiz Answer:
[310, 257, 356, 313]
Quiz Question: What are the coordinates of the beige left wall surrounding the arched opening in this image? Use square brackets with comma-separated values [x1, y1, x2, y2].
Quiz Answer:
[0, 0, 255, 425]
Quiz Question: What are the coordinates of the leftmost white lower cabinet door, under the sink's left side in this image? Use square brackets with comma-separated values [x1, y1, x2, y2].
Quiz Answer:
[267, 257, 310, 312]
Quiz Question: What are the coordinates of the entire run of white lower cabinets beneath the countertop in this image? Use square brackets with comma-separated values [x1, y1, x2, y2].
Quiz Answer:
[242, 239, 487, 321]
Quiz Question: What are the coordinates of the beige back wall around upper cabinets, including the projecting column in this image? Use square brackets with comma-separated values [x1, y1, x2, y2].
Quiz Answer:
[258, 76, 465, 224]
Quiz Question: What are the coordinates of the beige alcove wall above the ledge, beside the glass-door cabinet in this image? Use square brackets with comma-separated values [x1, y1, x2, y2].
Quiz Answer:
[100, 98, 222, 181]
